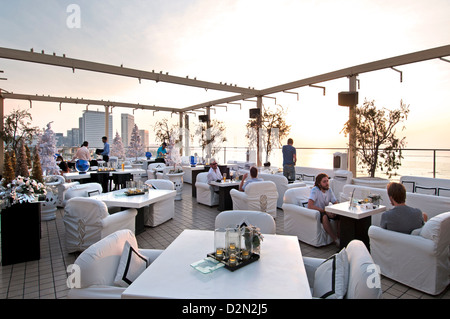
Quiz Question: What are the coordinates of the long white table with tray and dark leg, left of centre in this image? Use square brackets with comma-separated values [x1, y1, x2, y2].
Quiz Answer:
[92, 189, 177, 235]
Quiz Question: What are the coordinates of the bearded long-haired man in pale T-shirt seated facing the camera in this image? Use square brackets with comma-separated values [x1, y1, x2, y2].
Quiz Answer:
[308, 173, 340, 247]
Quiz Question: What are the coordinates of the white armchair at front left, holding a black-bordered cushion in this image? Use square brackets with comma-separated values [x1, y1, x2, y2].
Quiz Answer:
[67, 229, 163, 299]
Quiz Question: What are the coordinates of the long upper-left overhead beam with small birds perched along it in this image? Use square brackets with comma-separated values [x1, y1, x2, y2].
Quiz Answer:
[0, 47, 255, 94]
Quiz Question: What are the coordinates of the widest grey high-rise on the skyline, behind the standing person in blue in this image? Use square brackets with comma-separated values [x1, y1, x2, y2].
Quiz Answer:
[80, 111, 114, 148]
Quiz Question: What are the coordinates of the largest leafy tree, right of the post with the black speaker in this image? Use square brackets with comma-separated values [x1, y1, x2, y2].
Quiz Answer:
[342, 100, 409, 178]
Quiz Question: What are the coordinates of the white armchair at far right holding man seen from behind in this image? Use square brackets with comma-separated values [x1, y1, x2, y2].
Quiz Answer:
[369, 212, 450, 295]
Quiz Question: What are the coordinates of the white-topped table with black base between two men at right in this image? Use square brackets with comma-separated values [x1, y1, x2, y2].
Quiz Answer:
[325, 202, 386, 249]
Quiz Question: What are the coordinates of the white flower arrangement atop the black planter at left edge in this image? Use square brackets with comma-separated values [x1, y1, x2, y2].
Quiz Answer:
[0, 176, 47, 208]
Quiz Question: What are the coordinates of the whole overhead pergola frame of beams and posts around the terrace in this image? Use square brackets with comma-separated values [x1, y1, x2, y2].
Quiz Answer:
[0, 45, 450, 176]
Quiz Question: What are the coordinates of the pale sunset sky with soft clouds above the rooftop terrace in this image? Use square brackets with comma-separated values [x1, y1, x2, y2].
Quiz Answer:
[0, 0, 450, 154]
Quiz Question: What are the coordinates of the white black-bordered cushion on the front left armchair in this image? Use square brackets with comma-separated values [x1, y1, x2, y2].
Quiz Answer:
[114, 241, 149, 287]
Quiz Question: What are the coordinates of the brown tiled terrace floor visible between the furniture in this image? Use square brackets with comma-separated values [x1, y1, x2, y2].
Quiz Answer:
[0, 184, 450, 299]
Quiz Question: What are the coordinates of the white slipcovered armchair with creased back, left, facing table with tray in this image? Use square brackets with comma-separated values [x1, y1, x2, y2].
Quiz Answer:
[63, 197, 137, 253]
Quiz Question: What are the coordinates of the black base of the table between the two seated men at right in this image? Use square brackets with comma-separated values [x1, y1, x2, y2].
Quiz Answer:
[340, 216, 372, 251]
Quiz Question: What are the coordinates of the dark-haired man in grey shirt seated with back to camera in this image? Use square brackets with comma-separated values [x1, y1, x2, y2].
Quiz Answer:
[380, 182, 428, 234]
